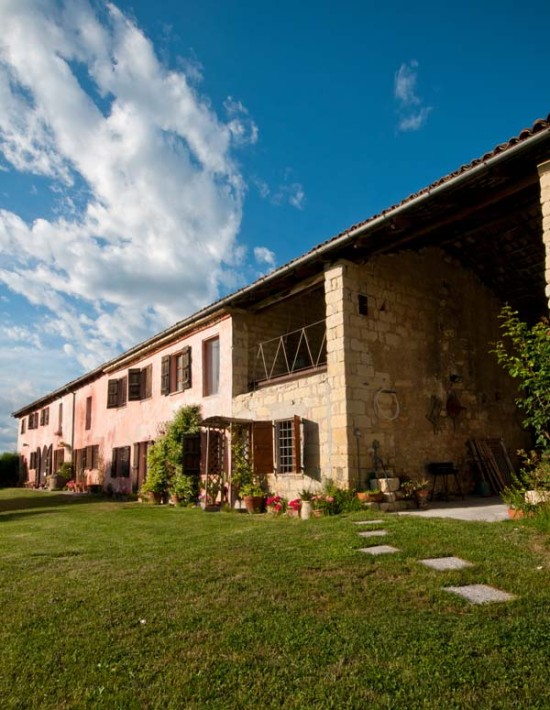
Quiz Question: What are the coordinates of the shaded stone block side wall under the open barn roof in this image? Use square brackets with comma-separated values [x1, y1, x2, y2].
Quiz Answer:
[338, 249, 527, 490]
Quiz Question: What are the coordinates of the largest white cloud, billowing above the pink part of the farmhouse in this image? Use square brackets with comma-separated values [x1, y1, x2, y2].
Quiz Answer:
[0, 0, 258, 448]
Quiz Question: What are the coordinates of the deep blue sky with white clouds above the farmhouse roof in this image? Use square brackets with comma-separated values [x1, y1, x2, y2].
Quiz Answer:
[0, 0, 550, 451]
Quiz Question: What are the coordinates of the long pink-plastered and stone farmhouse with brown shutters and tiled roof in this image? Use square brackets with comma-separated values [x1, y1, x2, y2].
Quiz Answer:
[13, 116, 550, 495]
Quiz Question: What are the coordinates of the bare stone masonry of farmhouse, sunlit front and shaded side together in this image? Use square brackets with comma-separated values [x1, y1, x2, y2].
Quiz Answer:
[233, 248, 528, 494]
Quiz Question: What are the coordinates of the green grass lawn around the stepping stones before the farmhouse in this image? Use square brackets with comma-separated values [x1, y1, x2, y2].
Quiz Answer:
[0, 489, 550, 710]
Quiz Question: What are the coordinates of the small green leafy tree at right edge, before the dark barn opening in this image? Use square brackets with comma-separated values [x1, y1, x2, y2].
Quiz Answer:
[494, 306, 550, 450]
